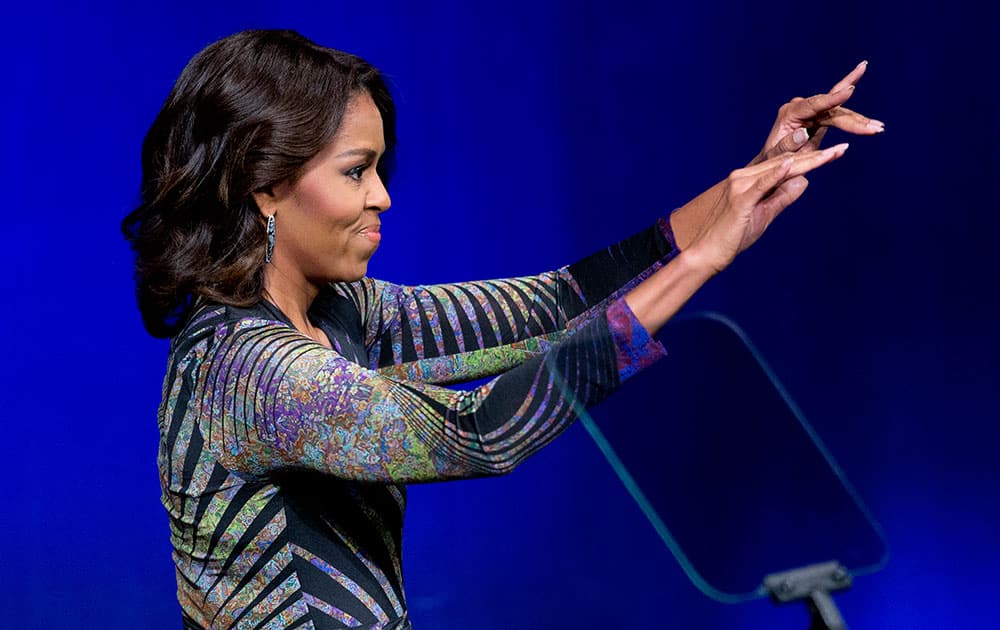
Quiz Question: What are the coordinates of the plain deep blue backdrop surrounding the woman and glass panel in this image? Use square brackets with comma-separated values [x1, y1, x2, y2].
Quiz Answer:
[0, 0, 1000, 629]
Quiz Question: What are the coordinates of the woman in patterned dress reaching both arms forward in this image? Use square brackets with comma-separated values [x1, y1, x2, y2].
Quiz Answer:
[123, 31, 883, 628]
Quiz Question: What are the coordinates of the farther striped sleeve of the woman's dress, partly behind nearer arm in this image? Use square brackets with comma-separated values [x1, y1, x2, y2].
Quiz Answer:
[336, 219, 677, 383]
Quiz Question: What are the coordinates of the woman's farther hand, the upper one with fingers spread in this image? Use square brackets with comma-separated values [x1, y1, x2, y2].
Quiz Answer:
[749, 61, 885, 166]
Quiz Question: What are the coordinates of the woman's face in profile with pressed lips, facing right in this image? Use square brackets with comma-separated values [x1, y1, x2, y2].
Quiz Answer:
[254, 92, 390, 286]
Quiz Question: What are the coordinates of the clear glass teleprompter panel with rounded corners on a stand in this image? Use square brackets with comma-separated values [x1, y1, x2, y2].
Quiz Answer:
[582, 314, 888, 603]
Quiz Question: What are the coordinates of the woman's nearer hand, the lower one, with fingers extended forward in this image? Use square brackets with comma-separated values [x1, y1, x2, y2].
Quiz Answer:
[686, 143, 848, 274]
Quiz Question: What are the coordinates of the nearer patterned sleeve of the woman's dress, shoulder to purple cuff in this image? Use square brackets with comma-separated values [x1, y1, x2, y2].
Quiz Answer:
[189, 301, 664, 482]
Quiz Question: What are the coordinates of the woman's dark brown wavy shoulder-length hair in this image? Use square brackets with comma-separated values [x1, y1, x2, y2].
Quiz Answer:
[122, 30, 396, 337]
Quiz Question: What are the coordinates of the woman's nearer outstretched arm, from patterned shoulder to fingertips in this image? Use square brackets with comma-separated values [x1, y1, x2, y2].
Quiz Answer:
[176, 69, 872, 482]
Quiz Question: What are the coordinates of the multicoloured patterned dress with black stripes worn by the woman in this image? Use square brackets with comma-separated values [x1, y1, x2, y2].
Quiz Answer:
[159, 220, 676, 628]
